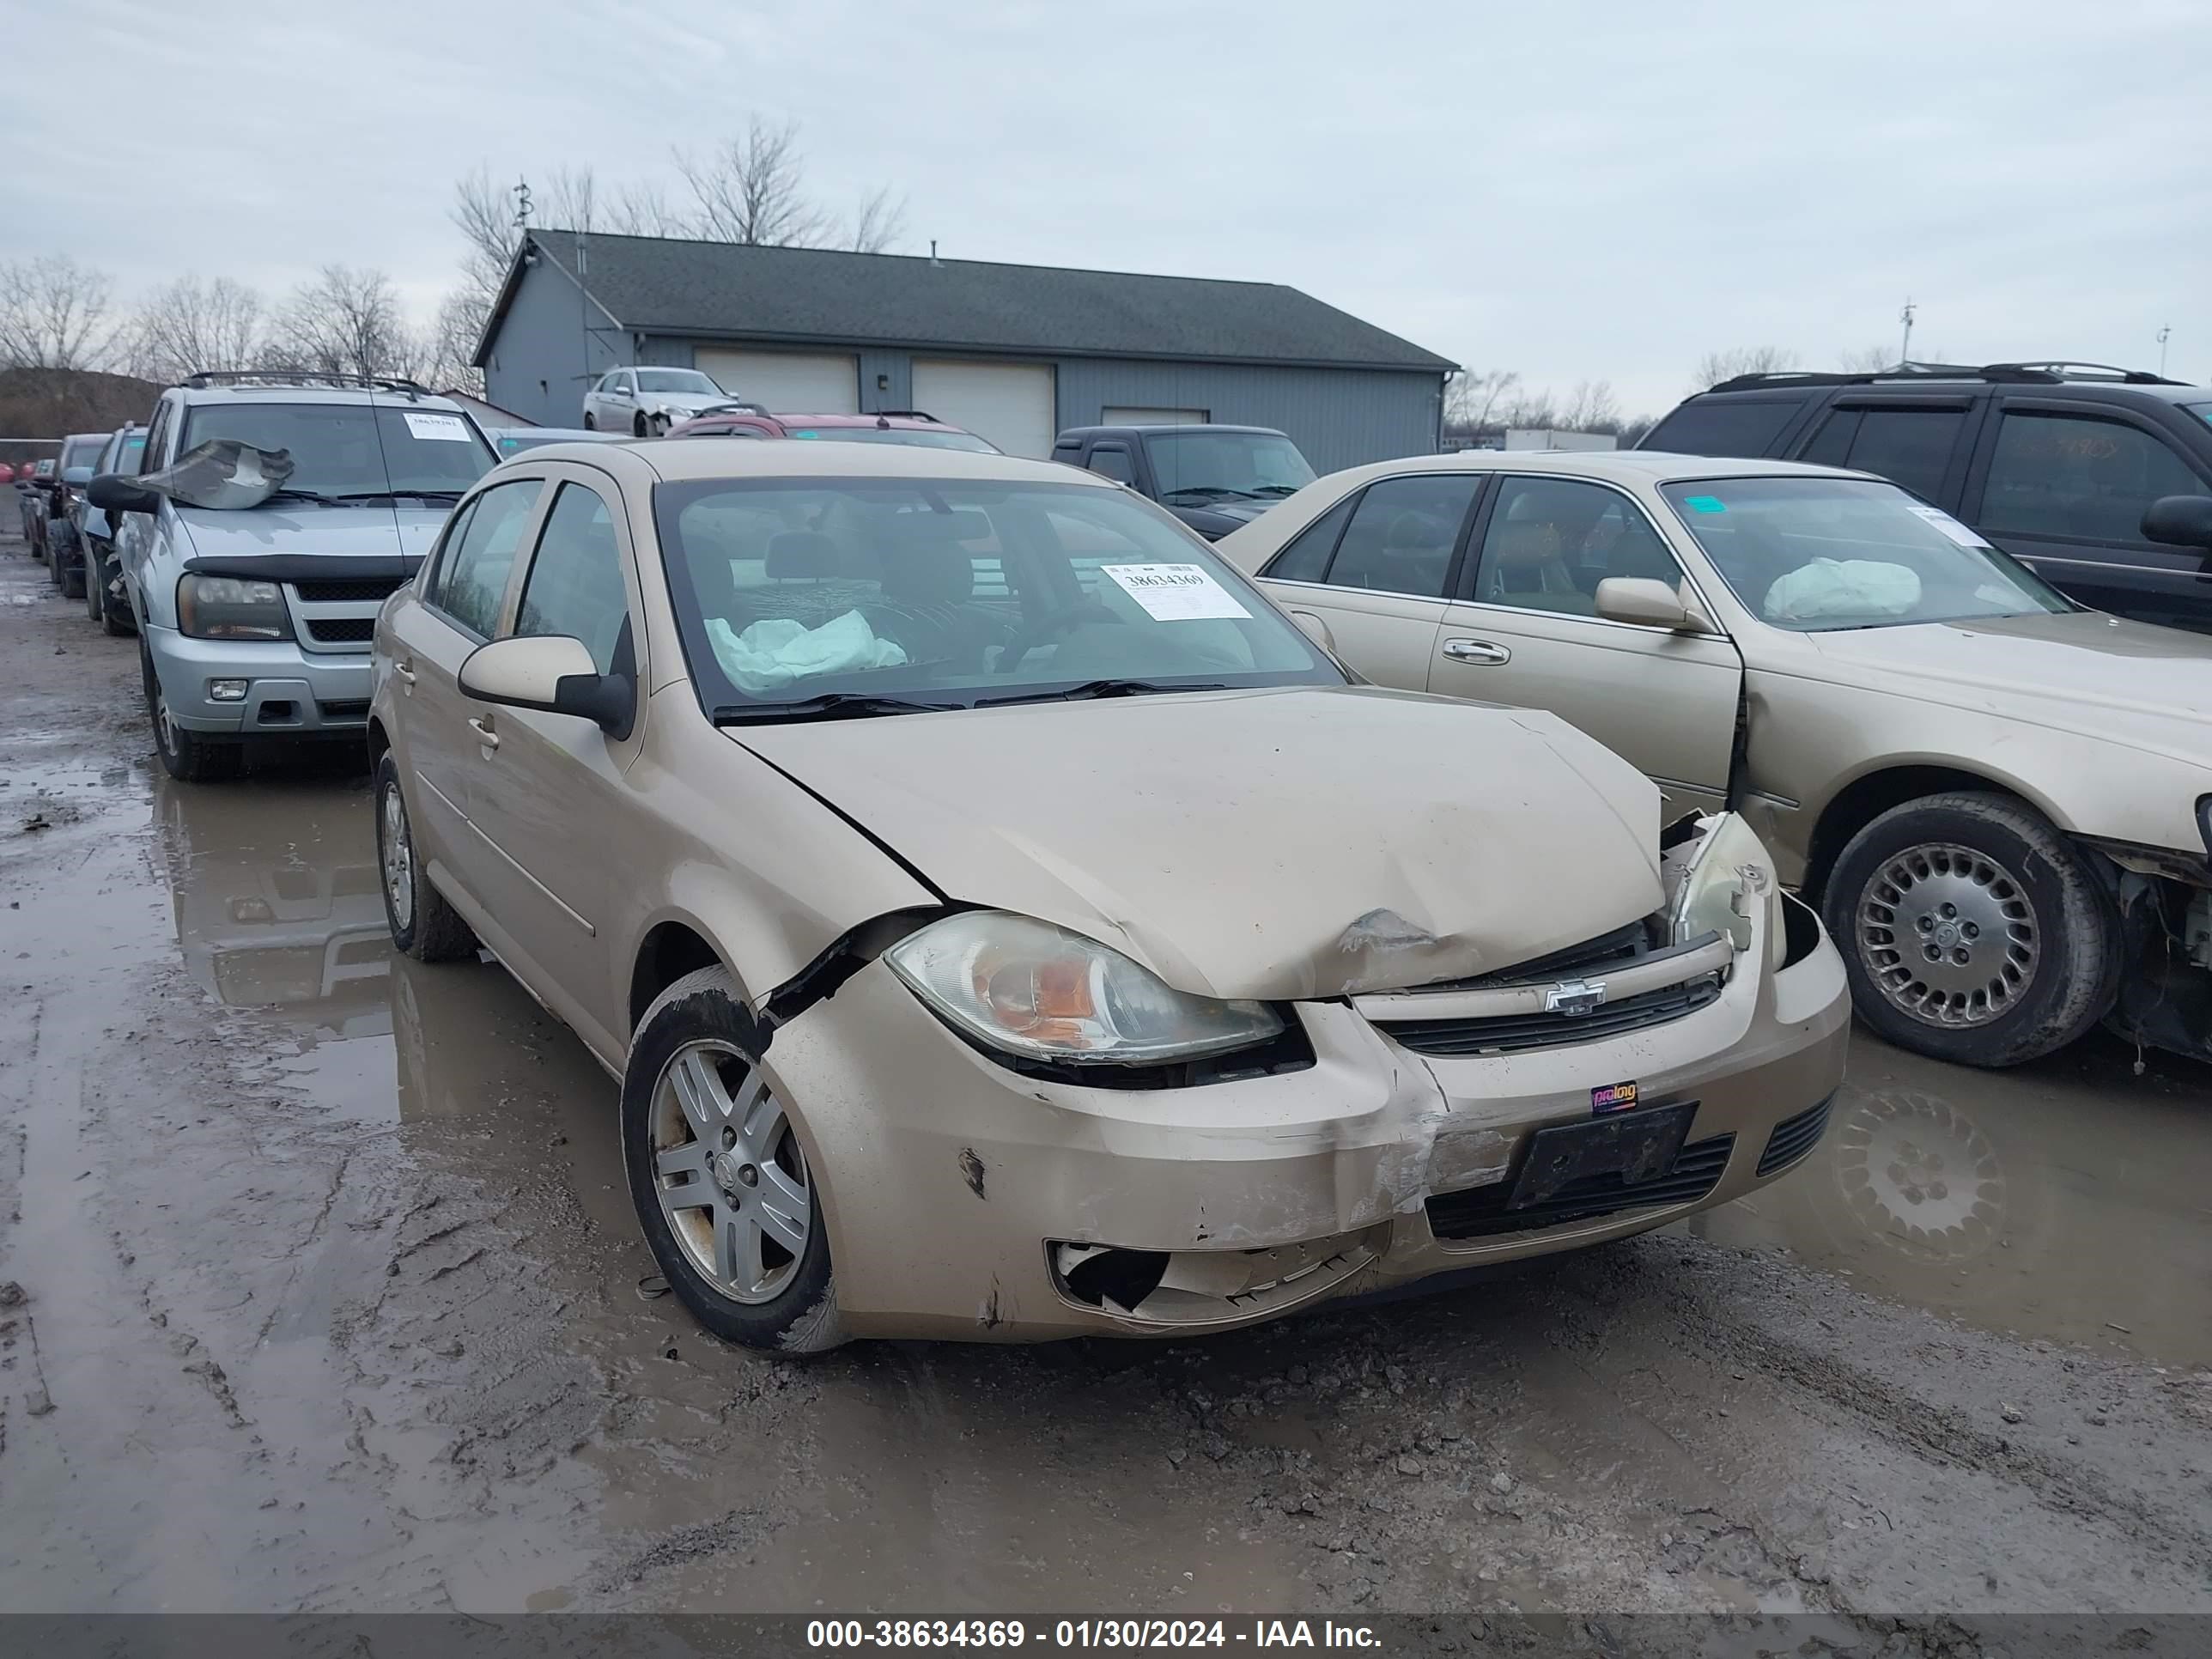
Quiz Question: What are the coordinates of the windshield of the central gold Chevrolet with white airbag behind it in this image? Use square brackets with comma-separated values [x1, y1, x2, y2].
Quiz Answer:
[653, 477, 1343, 719]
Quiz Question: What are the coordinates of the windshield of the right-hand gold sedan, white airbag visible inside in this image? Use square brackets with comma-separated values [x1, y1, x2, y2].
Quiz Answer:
[1662, 477, 2075, 633]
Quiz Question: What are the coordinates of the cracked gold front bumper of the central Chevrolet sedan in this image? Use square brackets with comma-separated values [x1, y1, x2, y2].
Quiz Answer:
[765, 862, 1850, 1340]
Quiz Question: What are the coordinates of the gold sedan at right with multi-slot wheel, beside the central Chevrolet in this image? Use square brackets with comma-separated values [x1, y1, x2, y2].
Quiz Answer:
[1218, 452, 2212, 1066]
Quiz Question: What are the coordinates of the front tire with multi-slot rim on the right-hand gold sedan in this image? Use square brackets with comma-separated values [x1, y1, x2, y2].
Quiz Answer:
[1823, 792, 2121, 1066]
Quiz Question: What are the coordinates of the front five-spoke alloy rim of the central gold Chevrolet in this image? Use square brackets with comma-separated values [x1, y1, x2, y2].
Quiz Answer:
[653, 1040, 814, 1303]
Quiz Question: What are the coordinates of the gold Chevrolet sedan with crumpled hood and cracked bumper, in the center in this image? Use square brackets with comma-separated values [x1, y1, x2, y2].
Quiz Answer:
[369, 441, 1847, 1352]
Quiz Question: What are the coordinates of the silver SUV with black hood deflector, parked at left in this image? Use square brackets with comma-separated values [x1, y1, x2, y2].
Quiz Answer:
[91, 372, 495, 781]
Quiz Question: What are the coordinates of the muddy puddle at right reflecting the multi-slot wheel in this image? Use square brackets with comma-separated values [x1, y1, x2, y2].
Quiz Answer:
[1687, 1030, 2212, 1364]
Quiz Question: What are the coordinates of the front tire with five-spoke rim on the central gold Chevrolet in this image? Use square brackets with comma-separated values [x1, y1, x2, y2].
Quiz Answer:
[622, 967, 845, 1354]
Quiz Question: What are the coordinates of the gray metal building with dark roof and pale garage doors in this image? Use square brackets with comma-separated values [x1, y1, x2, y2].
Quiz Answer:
[476, 230, 1453, 471]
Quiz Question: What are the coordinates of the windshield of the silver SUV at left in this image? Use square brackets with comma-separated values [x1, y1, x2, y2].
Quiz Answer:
[177, 403, 493, 495]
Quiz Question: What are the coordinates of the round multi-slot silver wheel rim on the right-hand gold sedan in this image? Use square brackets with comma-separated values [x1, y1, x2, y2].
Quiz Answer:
[1856, 842, 2042, 1026]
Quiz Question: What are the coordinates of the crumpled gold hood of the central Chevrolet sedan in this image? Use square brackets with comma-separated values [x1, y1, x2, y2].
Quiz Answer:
[730, 686, 1662, 1000]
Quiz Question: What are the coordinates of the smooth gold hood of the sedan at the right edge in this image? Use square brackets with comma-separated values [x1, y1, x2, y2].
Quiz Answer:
[1808, 611, 2212, 761]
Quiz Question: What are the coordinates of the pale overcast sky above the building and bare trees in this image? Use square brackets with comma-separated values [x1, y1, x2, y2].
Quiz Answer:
[0, 0, 2212, 411]
